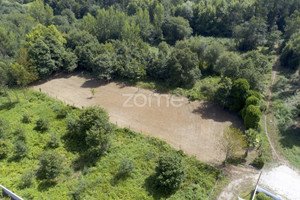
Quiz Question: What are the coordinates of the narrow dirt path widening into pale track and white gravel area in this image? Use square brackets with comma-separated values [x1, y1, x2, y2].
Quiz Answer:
[218, 56, 300, 200]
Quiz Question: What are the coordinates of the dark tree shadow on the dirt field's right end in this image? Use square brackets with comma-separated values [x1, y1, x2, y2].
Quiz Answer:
[193, 102, 243, 128]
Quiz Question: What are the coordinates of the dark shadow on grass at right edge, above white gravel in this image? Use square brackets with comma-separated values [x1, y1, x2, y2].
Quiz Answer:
[279, 125, 300, 149]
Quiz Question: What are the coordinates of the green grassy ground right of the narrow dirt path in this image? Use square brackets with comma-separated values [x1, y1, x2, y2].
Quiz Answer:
[267, 68, 300, 169]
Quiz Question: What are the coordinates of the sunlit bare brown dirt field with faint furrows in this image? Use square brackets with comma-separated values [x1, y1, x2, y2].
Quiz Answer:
[31, 74, 242, 164]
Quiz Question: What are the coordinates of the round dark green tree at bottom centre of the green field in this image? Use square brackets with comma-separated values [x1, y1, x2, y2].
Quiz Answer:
[156, 153, 185, 191]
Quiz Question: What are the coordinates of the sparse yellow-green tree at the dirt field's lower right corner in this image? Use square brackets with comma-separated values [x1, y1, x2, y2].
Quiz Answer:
[220, 127, 247, 167]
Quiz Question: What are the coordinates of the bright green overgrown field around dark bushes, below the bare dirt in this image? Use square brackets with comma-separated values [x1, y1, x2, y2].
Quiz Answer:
[0, 90, 222, 200]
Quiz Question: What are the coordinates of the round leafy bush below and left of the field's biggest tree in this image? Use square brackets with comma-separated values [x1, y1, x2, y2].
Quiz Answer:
[36, 151, 63, 180]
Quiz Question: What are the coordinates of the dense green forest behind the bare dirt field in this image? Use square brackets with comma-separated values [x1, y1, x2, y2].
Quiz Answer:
[0, 0, 300, 134]
